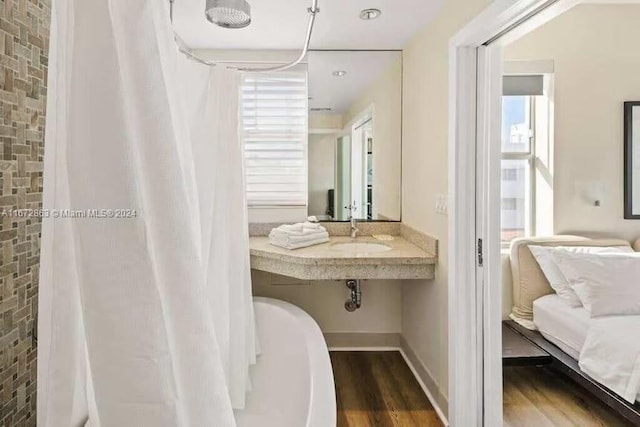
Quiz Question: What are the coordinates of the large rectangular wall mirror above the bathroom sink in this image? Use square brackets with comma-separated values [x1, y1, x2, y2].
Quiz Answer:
[308, 51, 402, 221]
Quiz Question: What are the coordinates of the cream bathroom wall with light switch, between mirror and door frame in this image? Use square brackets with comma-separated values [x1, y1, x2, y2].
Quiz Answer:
[402, 0, 490, 411]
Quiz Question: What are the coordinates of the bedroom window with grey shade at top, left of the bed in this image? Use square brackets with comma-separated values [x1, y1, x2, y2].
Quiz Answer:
[501, 75, 553, 247]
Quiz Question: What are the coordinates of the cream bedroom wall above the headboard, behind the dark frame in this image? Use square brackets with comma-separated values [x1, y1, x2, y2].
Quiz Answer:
[505, 4, 640, 241]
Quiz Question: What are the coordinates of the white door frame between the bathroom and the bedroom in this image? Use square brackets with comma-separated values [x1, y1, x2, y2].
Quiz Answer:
[448, 0, 584, 427]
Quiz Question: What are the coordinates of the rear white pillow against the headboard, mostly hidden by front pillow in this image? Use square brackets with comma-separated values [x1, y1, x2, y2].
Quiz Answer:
[529, 245, 633, 308]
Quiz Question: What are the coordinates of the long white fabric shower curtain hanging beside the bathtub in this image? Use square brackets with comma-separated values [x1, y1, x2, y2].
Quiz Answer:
[37, 0, 256, 427]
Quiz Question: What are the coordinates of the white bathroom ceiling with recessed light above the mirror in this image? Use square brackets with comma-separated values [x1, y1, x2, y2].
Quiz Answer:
[172, 0, 443, 49]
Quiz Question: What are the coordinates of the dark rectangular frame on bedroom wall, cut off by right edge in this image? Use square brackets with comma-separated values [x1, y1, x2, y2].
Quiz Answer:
[624, 101, 640, 219]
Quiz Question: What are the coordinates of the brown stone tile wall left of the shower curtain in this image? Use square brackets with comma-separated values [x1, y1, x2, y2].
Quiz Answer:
[0, 0, 51, 427]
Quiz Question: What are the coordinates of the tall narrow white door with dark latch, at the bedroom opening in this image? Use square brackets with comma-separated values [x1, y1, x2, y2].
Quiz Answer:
[476, 45, 503, 426]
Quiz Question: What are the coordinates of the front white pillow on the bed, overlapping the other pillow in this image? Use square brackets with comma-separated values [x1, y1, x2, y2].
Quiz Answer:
[556, 249, 640, 317]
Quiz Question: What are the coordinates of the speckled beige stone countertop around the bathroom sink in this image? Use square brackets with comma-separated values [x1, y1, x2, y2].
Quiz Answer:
[250, 236, 437, 280]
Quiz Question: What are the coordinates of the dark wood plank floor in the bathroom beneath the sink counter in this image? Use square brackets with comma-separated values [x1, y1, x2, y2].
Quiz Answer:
[331, 352, 442, 427]
